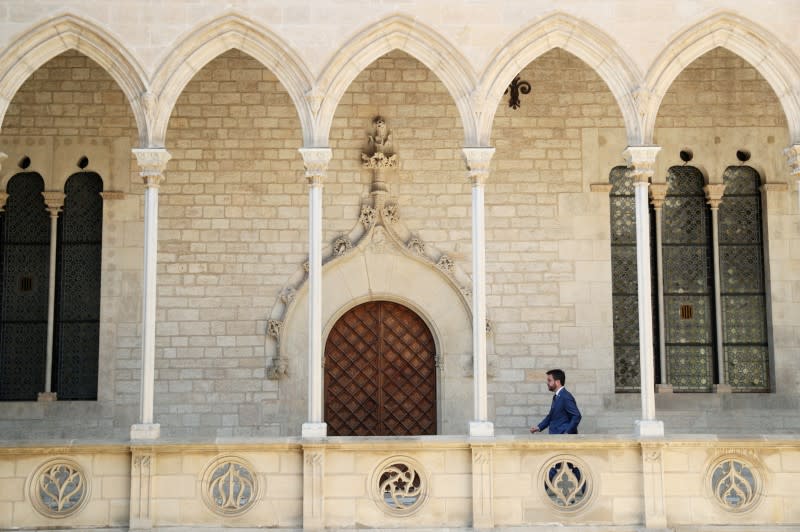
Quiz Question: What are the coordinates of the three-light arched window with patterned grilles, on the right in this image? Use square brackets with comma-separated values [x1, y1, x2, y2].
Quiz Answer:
[610, 166, 769, 392]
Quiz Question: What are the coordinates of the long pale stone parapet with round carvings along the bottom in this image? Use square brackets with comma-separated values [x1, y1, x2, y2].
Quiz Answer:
[0, 436, 800, 531]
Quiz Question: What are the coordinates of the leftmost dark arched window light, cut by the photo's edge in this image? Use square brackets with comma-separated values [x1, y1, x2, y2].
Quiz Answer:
[0, 172, 50, 401]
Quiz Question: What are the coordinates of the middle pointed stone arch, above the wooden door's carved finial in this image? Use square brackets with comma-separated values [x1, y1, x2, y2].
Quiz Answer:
[314, 15, 477, 146]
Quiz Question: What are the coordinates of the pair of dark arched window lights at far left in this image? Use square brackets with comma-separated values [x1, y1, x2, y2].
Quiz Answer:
[0, 172, 103, 401]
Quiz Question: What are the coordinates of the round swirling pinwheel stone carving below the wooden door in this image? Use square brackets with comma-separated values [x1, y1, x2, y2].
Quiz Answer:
[370, 456, 428, 516]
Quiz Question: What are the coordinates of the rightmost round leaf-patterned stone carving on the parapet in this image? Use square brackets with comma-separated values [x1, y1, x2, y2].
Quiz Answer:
[708, 456, 761, 512]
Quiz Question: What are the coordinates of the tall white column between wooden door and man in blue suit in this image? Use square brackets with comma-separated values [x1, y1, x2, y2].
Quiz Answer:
[464, 148, 494, 437]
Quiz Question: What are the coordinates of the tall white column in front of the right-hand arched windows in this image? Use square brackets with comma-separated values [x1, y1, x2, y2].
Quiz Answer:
[623, 146, 664, 436]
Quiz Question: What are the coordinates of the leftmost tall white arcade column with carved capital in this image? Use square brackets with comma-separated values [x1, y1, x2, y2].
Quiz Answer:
[131, 148, 171, 440]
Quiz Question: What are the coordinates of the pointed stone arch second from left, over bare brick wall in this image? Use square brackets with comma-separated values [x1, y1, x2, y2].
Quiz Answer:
[150, 14, 313, 146]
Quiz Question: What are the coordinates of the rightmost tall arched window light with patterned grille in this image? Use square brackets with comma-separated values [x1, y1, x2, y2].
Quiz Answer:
[719, 166, 770, 392]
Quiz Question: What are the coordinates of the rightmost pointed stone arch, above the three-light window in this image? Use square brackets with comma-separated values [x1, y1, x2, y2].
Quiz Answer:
[642, 13, 800, 144]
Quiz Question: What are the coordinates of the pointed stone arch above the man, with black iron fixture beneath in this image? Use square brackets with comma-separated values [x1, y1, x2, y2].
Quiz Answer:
[476, 13, 641, 146]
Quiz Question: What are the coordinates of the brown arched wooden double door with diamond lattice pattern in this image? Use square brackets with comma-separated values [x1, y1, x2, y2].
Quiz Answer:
[325, 301, 436, 436]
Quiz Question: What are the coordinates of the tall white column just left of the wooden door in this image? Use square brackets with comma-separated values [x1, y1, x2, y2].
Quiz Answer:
[300, 148, 332, 438]
